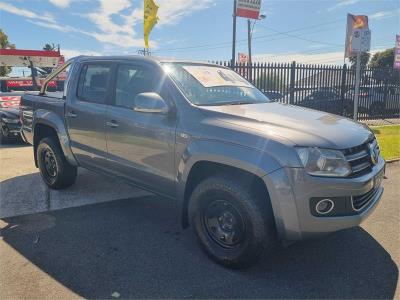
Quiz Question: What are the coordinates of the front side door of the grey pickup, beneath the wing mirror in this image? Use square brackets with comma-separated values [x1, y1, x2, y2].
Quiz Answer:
[106, 63, 176, 195]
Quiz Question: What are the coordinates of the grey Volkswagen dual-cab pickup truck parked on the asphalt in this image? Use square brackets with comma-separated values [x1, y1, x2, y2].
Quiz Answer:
[20, 56, 385, 268]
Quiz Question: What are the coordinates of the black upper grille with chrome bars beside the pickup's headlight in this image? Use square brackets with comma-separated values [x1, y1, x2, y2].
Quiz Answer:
[343, 139, 379, 177]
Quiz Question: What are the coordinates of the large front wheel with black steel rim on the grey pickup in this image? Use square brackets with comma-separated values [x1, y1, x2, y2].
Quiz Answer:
[189, 175, 277, 268]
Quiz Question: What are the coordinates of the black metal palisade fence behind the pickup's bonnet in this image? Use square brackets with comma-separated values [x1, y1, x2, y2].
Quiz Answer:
[215, 62, 400, 120]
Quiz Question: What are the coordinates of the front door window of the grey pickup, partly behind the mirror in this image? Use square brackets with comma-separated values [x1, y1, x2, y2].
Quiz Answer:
[115, 65, 155, 109]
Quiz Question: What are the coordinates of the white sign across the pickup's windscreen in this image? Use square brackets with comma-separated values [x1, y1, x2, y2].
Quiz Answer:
[183, 66, 252, 88]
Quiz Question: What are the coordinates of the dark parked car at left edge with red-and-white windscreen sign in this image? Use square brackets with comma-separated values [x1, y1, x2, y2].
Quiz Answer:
[0, 92, 23, 144]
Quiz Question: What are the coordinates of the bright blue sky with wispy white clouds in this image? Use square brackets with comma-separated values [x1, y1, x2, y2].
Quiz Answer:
[0, 0, 400, 74]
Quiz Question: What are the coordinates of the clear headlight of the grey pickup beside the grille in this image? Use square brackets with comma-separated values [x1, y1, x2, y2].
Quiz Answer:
[296, 147, 351, 177]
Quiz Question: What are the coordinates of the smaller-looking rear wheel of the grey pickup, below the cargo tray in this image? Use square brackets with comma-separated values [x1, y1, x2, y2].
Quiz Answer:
[36, 137, 77, 189]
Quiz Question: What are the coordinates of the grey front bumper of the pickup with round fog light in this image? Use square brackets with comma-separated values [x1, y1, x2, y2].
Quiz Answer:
[263, 158, 385, 241]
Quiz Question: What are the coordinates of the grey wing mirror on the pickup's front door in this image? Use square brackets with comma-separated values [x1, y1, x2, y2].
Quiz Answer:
[133, 93, 169, 115]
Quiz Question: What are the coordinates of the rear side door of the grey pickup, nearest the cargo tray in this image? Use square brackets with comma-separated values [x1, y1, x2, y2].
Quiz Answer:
[66, 61, 113, 169]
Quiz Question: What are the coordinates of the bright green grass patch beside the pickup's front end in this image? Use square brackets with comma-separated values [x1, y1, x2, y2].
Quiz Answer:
[371, 125, 400, 160]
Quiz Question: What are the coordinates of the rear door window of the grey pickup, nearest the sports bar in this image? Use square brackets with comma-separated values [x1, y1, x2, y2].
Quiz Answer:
[77, 64, 111, 103]
